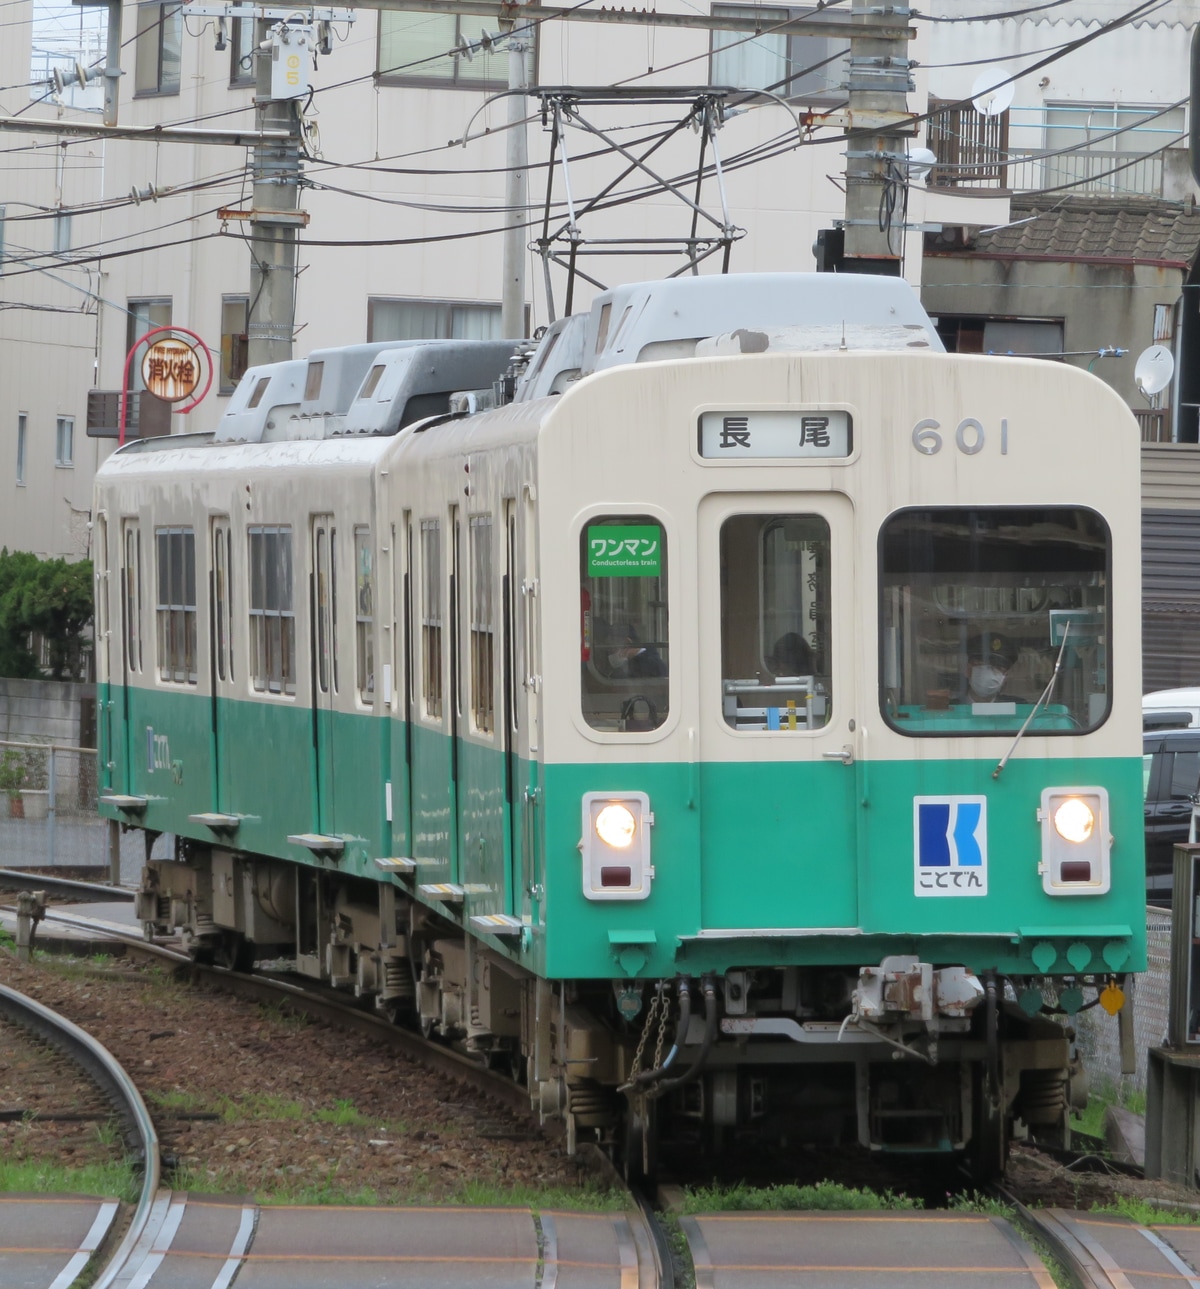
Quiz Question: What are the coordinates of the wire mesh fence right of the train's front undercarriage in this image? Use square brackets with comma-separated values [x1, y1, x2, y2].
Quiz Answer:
[1075, 909, 1170, 1097]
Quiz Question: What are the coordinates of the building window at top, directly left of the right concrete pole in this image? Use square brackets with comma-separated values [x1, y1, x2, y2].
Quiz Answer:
[711, 4, 849, 103]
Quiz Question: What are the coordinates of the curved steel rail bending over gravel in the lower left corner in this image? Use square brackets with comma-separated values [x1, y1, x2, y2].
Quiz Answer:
[0, 985, 162, 1289]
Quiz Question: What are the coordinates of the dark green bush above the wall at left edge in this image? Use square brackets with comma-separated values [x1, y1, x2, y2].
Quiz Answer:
[0, 547, 92, 681]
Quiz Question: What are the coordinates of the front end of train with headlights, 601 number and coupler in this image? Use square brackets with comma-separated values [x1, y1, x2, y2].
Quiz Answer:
[536, 340, 1146, 1174]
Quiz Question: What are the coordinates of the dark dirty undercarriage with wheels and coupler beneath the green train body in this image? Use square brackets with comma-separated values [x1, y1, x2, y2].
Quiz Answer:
[138, 839, 1087, 1179]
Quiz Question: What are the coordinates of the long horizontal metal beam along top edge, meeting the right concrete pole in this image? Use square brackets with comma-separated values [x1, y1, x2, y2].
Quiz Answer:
[342, 0, 916, 41]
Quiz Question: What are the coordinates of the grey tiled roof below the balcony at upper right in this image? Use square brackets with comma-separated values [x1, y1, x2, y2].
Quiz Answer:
[972, 196, 1200, 264]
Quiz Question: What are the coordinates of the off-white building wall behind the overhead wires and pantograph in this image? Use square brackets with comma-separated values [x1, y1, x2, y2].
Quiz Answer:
[9, 0, 927, 554]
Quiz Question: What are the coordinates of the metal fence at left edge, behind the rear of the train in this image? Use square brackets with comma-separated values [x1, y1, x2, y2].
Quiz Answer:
[0, 741, 164, 884]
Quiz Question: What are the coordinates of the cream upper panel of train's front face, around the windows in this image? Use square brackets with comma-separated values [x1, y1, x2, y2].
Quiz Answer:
[537, 352, 1141, 761]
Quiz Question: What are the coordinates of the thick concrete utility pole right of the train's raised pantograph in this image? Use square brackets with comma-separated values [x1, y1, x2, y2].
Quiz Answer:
[840, 0, 911, 275]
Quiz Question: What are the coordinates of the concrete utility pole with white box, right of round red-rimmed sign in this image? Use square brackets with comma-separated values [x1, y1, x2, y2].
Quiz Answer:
[246, 18, 308, 367]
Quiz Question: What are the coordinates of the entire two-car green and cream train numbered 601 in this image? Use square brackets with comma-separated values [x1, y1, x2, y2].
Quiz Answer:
[94, 275, 1146, 1173]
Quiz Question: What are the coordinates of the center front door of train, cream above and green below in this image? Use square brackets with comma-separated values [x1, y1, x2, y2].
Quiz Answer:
[699, 494, 874, 931]
